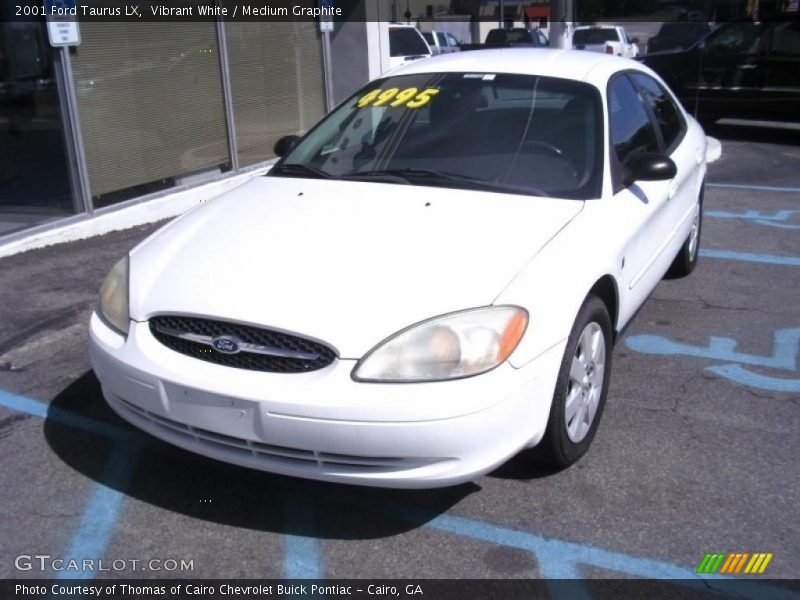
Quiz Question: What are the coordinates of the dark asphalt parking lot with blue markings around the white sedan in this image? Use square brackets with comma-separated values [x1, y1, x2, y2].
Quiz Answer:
[0, 118, 800, 598]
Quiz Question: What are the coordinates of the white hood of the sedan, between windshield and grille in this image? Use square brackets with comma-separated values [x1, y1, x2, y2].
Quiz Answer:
[130, 177, 583, 358]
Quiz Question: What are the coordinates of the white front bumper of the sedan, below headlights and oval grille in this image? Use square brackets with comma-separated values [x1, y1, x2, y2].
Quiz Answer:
[90, 314, 564, 488]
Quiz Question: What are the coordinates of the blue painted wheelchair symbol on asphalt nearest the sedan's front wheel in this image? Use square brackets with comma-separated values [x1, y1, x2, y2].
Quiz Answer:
[625, 328, 800, 393]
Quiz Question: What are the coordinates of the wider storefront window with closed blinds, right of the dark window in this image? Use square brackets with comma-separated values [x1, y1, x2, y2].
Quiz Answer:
[72, 22, 231, 207]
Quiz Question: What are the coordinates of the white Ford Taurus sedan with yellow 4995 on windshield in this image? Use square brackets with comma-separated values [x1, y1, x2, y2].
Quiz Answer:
[91, 49, 706, 487]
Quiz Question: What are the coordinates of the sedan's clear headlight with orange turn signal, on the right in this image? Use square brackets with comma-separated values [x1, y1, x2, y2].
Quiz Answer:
[353, 306, 528, 382]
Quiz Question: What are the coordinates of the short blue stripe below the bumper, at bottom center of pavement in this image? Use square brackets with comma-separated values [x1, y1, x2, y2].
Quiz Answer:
[283, 496, 324, 579]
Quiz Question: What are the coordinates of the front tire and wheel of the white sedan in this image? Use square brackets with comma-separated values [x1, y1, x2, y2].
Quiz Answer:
[539, 295, 613, 469]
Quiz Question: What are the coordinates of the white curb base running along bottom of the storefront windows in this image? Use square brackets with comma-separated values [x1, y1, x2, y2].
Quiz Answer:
[0, 167, 269, 258]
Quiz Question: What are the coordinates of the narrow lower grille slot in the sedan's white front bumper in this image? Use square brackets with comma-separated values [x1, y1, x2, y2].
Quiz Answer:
[114, 396, 434, 472]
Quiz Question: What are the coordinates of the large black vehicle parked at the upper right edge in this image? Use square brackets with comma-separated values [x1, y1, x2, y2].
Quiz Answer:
[641, 13, 800, 122]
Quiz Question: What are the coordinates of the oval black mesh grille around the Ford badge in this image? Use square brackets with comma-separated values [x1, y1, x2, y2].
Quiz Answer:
[150, 315, 336, 373]
